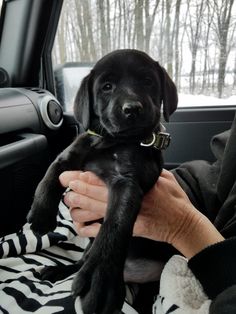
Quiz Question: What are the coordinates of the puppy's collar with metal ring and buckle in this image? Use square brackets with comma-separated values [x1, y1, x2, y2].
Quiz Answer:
[87, 126, 171, 150]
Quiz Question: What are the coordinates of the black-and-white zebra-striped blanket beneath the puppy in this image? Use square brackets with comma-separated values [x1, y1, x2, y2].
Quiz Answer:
[0, 202, 208, 314]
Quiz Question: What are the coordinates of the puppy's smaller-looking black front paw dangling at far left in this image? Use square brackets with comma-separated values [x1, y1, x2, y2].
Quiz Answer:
[27, 200, 57, 234]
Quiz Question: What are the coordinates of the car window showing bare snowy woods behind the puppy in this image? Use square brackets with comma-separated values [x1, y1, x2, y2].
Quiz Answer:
[52, 0, 236, 109]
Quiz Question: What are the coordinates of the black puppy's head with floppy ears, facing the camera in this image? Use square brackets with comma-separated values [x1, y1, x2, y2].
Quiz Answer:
[74, 50, 178, 137]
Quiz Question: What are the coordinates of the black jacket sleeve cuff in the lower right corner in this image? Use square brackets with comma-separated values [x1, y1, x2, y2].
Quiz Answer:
[188, 237, 236, 314]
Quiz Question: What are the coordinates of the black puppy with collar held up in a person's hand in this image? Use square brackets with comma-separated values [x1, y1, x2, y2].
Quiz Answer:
[28, 50, 177, 314]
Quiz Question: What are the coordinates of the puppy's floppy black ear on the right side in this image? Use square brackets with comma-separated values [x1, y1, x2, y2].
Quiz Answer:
[157, 62, 178, 122]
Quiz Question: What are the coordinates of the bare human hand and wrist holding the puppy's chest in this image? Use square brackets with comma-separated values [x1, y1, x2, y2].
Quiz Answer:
[60, 170, 223, 257]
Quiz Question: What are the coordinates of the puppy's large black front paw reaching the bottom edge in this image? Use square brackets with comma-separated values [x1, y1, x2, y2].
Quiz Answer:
[72, 258, 125, 314]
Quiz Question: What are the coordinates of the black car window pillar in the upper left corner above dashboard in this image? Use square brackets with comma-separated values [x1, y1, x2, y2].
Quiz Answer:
[0, 0, 63, 93]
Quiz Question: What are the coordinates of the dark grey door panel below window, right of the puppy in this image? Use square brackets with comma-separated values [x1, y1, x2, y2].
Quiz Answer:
[164, 107, 235, 169]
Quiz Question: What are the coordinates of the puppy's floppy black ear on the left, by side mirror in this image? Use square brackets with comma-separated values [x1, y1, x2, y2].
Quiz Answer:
[74, 71, 93, 130]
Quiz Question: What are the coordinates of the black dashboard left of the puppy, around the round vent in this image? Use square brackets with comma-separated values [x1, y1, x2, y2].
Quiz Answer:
[0, 88, 61, 235]
